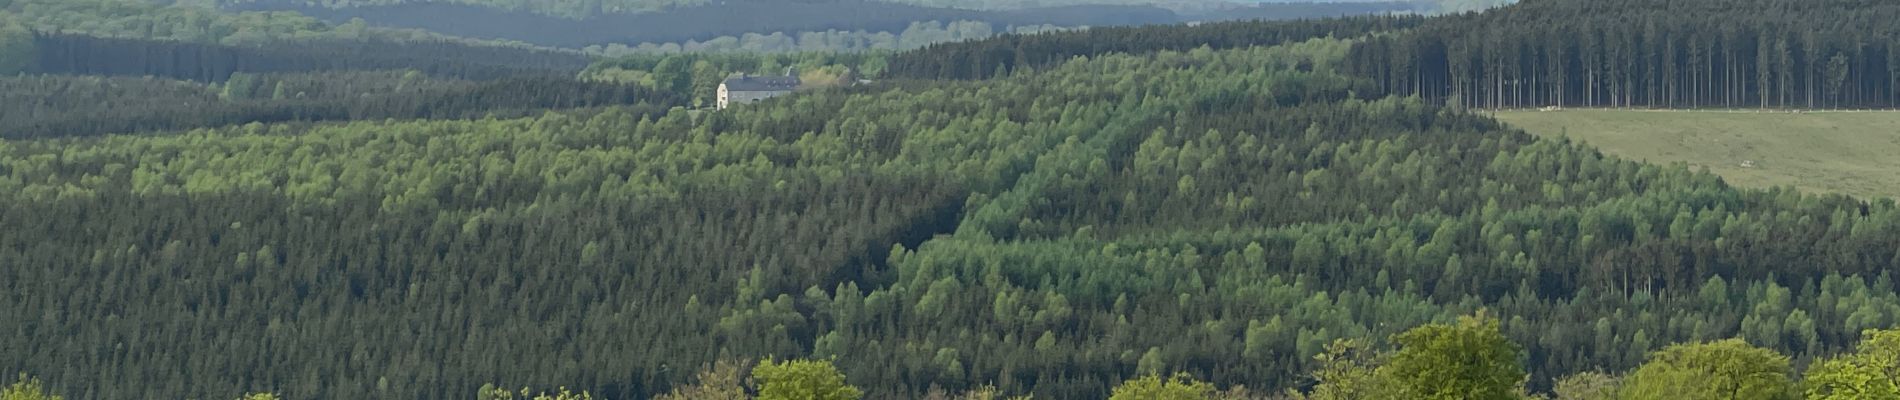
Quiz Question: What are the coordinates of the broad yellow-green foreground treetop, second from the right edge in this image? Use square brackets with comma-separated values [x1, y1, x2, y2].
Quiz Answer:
[1621, 339, 1794, 400]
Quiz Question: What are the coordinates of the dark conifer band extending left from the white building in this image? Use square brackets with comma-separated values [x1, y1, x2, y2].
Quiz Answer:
[0, 72, 686, 138]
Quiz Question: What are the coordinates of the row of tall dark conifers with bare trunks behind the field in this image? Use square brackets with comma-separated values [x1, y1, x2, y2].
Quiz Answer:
[1345, 0, 1900, 108]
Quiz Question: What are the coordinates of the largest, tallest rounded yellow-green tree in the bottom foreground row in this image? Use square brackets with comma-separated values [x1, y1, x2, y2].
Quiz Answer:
[1378, 313, 1524, 400]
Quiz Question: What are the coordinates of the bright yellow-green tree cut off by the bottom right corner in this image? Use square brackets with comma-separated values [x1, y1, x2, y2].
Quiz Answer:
[1805, 330, 1900, 400]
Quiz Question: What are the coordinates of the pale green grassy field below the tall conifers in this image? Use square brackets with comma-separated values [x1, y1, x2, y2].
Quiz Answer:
[1497, 110, 1900, 197]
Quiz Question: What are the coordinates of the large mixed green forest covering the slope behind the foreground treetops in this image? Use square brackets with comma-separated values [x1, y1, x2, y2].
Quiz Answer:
[11, 33, 1900, 398]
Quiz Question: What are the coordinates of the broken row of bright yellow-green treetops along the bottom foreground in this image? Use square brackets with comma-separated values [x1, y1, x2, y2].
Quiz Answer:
[22, 311, 1900, 400]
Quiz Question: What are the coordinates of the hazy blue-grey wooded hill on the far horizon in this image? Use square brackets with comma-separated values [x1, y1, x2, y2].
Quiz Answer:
[230, 0, 1182, 47]
